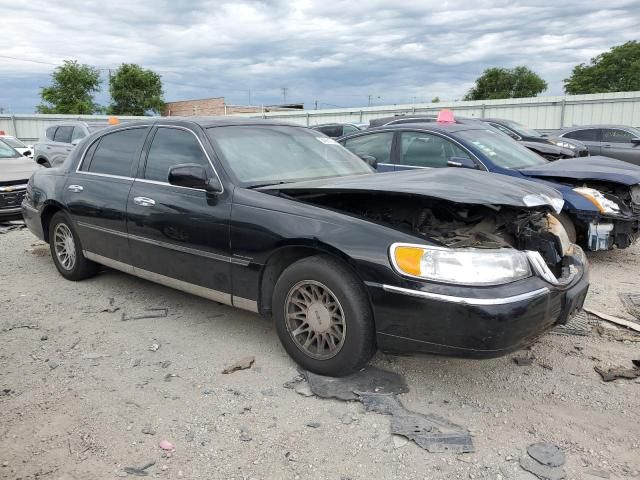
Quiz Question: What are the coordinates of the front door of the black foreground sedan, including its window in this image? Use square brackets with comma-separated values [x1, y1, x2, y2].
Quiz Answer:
[127, 126, 231, 303]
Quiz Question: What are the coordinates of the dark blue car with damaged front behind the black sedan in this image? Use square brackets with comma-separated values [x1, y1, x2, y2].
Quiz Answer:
[338, 119, 640, 250]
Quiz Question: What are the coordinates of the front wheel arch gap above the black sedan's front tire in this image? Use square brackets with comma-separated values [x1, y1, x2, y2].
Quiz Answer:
[258, 245, 358, 317]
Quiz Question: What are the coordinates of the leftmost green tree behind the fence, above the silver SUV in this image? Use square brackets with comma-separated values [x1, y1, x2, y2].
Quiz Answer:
[36, 60, 100, 114]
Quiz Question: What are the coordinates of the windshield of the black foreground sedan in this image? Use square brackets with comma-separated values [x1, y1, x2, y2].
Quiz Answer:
[207, 125, 372, 187]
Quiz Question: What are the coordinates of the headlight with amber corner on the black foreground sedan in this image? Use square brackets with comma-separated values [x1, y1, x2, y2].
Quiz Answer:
[390, 243, 531, 285]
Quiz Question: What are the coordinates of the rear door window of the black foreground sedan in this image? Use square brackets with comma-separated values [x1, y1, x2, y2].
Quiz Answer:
[85, 127, 147, 177]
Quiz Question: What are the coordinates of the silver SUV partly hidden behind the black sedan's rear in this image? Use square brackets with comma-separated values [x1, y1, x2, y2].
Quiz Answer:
[33, 120, 109, 167]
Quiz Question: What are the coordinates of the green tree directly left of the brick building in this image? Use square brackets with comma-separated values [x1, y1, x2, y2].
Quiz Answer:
[108, 63, 164, 115]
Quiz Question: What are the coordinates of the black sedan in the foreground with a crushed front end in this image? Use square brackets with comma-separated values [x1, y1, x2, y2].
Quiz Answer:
[22, 117, 588, 375]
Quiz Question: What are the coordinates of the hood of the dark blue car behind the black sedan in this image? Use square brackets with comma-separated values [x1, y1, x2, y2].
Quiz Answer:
[520, 156, 640, 185]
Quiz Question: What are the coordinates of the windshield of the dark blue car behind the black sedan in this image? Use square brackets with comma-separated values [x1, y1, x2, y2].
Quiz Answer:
[457, 130, 548, 170]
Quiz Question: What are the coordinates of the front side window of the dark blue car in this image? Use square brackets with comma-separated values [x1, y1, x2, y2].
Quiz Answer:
[400, 132, 471, 168]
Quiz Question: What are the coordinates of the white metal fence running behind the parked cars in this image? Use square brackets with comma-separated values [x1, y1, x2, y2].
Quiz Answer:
[5, 92, 640, 142]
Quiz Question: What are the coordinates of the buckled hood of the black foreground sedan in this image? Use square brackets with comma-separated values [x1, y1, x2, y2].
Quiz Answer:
[260, 168, 562, 210]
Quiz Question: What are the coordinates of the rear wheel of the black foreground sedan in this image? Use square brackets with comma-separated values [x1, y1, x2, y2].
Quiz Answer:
[49, 212, 100, 281]
